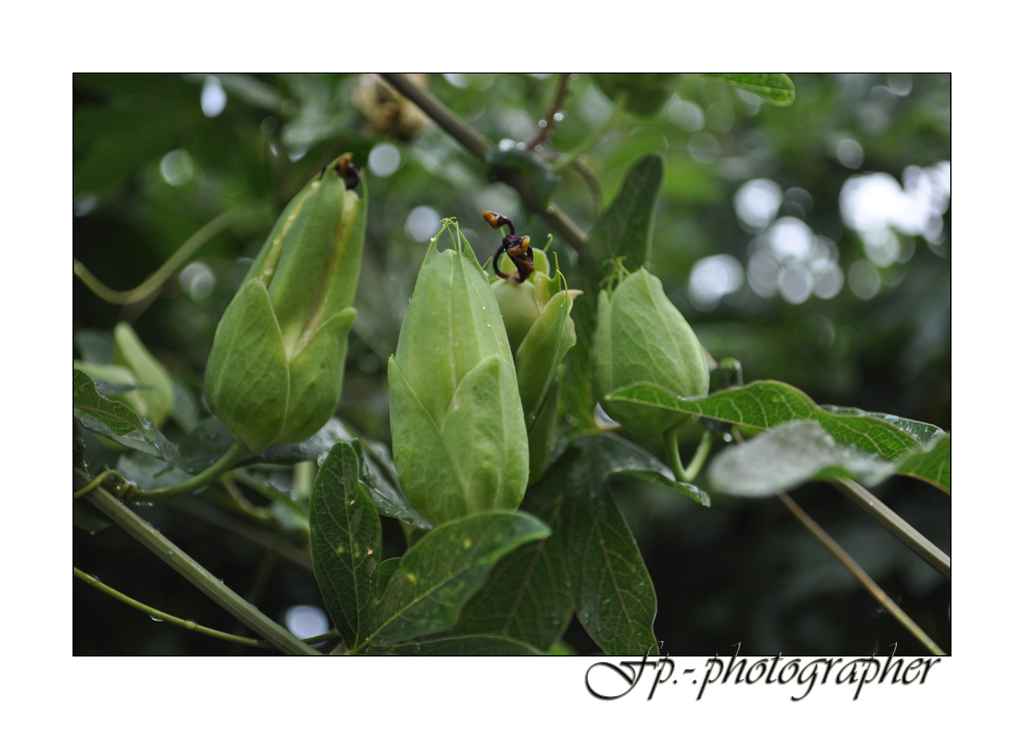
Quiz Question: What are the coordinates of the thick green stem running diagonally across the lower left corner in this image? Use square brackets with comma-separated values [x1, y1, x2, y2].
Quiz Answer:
[86, 488, 319, 655]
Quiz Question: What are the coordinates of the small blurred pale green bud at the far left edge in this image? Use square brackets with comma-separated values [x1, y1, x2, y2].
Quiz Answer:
[75, 321, 174, 428]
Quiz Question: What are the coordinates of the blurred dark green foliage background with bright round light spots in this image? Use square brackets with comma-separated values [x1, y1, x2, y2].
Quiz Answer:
[74, 74, 952, 655]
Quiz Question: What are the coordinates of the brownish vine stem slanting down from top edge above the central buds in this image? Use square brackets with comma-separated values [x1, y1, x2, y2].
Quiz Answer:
[381, 74, 587, 253]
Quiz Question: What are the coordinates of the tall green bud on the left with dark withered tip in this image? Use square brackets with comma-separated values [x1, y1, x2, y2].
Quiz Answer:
[206, 155, 367, 453]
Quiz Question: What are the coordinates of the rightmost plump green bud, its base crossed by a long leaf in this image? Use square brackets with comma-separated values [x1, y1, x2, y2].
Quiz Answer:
[594, 268, 708, 436]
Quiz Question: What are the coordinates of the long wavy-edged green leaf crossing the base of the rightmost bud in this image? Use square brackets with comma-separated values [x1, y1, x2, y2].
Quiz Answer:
[607, 380, 921, 461]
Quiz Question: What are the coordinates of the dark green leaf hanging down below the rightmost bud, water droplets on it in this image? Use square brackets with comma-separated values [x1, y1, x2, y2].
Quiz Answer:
[559, 434, 657, 655]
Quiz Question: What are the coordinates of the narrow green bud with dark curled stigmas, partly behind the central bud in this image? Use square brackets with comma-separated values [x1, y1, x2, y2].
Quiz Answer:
[490, 232, 580, 484]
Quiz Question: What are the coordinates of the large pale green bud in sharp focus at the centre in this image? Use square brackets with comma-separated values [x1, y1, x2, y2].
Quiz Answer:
[388, 221, 528, 523]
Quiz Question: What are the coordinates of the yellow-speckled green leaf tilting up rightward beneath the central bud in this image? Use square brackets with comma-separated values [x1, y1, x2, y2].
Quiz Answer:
[373, 511, 550, 644]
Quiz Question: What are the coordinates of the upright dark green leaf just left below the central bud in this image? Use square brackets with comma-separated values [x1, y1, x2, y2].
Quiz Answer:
[309, 442, 381, 648]
